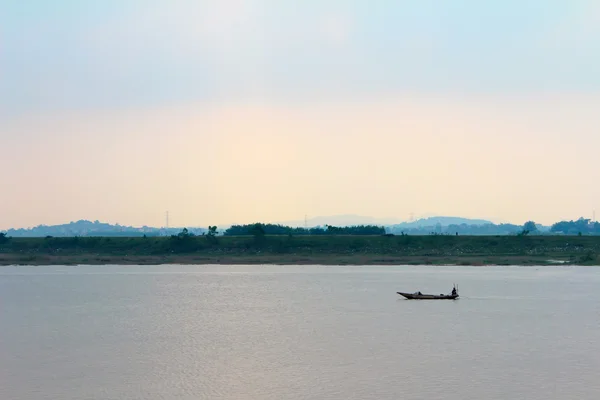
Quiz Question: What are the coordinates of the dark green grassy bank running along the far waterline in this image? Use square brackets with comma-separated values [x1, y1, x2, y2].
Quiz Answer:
[0, 236, 600, 265]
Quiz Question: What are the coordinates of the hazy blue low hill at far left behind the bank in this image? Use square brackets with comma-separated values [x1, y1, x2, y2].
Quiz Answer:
[6, 220, 206, 237]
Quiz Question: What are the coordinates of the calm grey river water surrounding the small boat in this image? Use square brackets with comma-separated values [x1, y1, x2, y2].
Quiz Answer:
[0, 266, 600, 400]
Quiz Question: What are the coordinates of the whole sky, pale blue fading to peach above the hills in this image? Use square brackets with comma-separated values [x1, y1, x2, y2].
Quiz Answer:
[0, 0, 600, 229]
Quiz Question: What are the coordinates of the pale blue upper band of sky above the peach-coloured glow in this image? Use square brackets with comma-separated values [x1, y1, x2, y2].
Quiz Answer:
[0, 0, 600, 111]
